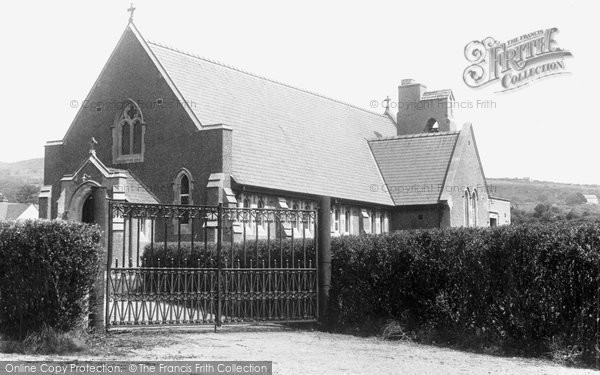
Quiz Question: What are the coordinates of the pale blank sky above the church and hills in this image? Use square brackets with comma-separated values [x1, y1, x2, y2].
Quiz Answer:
[0, 0, 600, 184]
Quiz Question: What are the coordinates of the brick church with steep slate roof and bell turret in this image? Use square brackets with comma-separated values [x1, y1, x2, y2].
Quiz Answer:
[39, 22, 510, 236]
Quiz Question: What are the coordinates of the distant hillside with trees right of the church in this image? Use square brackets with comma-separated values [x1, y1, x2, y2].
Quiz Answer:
[487, 178, 600, 211]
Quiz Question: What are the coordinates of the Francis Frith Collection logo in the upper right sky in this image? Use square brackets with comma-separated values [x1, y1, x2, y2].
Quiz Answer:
[463, 28, 572, 92]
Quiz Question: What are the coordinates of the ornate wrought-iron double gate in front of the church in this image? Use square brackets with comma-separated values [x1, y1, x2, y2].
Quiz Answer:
[105, 201, 319, 328]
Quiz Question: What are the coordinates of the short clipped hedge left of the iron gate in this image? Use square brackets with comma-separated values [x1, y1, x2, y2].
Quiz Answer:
[0, 220, 102, 337]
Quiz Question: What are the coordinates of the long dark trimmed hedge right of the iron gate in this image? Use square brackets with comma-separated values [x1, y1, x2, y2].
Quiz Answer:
[327, 224, 600, 358]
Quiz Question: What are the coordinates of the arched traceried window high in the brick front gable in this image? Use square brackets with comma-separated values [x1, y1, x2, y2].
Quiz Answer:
[113, 100, 145, 164]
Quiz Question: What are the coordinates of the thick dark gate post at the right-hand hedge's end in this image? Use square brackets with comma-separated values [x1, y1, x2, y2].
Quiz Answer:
[317, 197, 331, 322]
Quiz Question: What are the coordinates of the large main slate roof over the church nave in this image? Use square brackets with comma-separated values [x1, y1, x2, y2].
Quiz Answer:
[147, 37, 396, 205]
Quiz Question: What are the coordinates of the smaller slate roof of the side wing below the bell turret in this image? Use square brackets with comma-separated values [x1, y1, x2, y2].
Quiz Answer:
[369, 131, 460, 206]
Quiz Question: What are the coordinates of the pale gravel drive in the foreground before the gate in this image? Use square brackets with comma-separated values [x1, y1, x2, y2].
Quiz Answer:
[0, 327, 600, 375]
